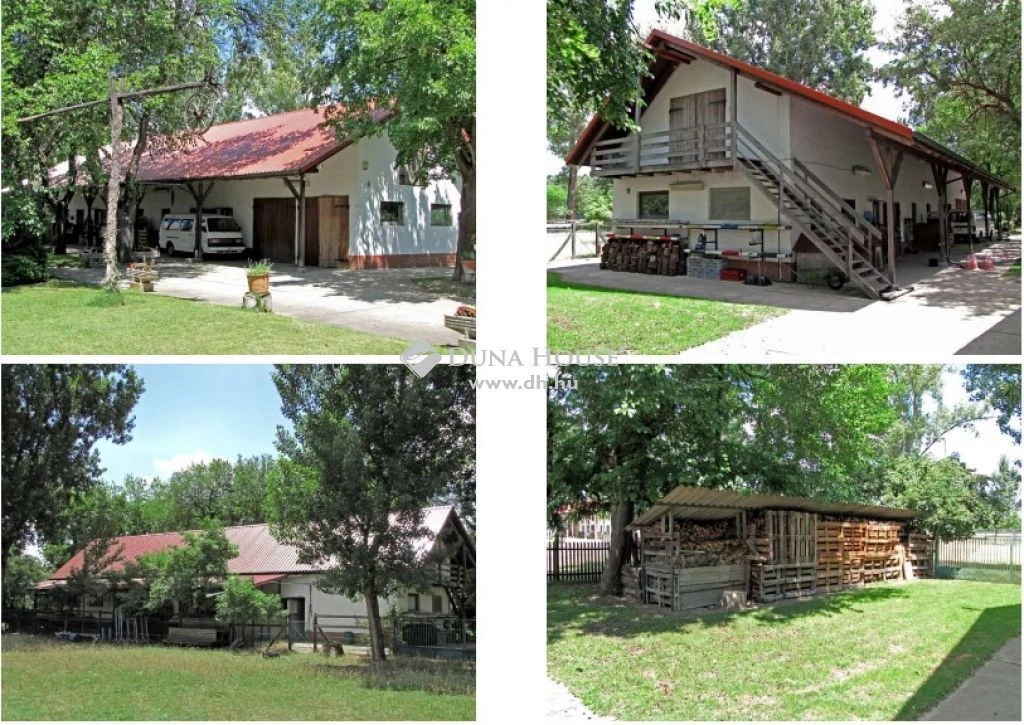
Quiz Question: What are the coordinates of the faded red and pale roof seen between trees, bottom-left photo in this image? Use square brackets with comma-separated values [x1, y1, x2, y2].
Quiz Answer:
[42, 506, 475, 588]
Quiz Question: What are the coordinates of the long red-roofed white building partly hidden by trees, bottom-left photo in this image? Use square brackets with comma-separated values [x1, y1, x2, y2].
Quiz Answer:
[36, 506, 476, 639]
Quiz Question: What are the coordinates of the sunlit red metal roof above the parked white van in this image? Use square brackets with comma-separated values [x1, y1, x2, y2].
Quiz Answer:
[138, 109, 391, 182]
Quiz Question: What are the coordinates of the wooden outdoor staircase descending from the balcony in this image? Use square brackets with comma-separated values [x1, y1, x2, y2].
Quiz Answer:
[735, 124, 901, 300]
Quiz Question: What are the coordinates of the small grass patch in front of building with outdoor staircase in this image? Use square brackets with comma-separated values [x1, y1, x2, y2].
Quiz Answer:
[548, 272, 786, 355]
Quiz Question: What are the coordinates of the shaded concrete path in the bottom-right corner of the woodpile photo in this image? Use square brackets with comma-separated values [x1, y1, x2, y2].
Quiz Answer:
[921, 637, 1021, 722]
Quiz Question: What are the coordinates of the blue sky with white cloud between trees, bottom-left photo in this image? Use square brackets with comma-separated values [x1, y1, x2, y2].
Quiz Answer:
[96, 365, 287, 483]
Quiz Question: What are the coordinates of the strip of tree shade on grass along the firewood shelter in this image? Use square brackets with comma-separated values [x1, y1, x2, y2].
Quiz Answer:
[548, 585, 908, 643]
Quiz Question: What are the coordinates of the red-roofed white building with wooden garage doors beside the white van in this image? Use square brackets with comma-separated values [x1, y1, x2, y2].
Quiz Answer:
[57, 109, 460, 269]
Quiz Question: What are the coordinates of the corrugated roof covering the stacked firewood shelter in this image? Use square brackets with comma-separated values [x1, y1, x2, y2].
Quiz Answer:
[630, 485, 918, 527]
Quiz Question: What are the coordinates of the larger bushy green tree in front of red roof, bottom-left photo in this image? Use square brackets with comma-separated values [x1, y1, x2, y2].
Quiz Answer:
[145, 522, 239, 617]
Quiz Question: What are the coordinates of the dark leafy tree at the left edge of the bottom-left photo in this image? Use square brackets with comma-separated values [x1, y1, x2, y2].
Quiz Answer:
[0, 365, 143, 567]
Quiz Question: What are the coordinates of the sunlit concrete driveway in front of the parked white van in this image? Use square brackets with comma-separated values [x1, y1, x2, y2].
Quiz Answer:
[54, 257, 475, 346]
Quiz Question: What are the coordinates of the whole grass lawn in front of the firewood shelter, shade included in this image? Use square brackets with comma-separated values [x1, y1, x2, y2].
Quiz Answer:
[548, 580, 1021, 720]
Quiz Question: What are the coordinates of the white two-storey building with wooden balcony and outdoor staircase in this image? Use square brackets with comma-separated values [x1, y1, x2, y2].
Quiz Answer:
[565, 30, 1013, 299]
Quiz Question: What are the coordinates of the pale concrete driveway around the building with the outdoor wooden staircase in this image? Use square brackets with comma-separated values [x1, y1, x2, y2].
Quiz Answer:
[551, 237, 1021, 363]
